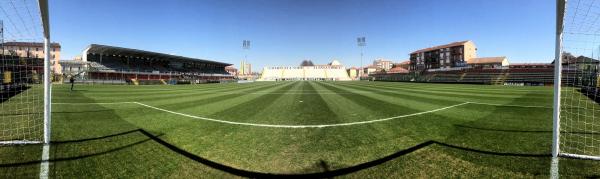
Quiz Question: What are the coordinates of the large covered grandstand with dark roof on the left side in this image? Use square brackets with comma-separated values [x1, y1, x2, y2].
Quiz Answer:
[74, 44, 234, 85]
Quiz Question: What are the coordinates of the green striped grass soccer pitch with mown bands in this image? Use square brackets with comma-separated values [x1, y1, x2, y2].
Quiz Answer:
[0, 81, 600, 178]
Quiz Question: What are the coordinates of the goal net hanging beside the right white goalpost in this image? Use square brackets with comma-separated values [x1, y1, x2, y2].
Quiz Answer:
[554, 0, 600, 160]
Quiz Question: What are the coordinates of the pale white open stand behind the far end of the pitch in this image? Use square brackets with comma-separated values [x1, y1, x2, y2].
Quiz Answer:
[257, 60, 351, 81]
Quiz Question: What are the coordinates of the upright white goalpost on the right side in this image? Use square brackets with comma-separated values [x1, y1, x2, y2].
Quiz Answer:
[552, 0, 567, 158]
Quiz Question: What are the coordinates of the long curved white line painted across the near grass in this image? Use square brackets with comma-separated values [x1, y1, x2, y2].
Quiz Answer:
[53, 102, 546, 128]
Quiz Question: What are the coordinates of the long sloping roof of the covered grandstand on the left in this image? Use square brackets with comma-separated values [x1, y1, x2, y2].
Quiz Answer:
[86, 44, 232, 66]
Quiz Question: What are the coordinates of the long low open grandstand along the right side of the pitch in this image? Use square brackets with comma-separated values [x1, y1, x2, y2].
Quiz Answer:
[371, 53, 600, 86]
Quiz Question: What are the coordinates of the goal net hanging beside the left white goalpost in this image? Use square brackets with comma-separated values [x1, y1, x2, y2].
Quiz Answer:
[0, 0, 47, 145]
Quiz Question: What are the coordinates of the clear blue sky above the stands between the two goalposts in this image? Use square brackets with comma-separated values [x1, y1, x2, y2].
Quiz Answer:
[50, 0, 555, 69]
